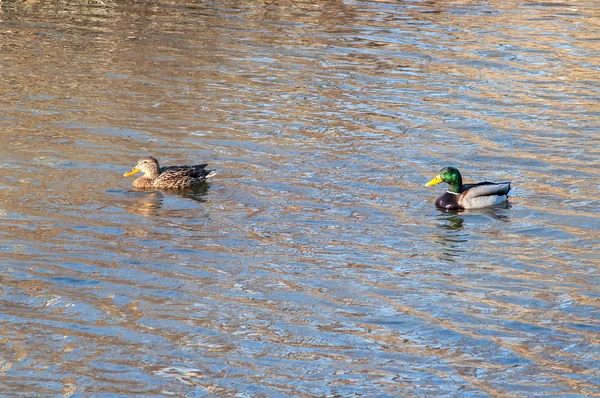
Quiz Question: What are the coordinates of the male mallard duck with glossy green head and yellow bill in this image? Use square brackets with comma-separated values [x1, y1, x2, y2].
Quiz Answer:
[425, 167, 510, 210]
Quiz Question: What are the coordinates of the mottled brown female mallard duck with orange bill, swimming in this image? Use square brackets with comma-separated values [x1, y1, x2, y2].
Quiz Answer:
[123, 156, 215, 189]
